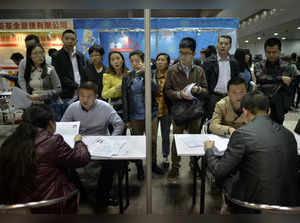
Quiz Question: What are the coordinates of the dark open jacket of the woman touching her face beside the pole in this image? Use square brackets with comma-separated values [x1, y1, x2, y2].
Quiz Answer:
[122, 71, 159, 123]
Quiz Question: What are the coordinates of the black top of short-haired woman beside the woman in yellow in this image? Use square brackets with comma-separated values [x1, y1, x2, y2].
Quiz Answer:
[84, 63, 106, 100]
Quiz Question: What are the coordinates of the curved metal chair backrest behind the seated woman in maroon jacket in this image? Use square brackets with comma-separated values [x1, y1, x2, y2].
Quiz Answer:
[0, 190, 79, 214]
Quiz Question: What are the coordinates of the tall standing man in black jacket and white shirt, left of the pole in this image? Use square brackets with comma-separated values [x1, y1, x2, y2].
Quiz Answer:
[52, 29, 87, 111]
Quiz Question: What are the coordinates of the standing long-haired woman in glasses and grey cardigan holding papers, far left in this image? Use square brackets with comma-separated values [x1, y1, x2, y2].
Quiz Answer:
[19, 44, 62, 120]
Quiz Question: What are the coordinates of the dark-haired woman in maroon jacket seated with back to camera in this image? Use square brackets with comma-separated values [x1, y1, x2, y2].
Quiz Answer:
[0, 104, 90, 214]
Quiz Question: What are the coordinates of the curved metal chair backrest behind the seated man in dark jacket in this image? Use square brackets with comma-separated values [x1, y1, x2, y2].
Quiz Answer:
[225, 193, 300, 214]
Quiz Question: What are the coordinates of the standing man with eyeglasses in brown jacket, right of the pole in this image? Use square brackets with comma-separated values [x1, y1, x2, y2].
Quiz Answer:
[165, 37, 207, 182]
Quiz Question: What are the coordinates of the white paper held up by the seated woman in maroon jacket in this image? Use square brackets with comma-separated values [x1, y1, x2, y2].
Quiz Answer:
[55, 122, 80, 148]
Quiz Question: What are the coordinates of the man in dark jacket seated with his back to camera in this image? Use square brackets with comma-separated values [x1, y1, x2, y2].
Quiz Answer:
[205, 92, 299, 213]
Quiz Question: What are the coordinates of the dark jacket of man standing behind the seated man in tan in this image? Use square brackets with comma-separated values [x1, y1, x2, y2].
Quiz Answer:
[202, 55, 240, 94]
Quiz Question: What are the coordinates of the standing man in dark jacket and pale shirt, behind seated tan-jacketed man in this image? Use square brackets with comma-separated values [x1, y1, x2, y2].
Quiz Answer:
[202, 35, 239, 119]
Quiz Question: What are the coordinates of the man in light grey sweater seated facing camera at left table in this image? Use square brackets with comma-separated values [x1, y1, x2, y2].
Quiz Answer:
[61, 81, 124, 206]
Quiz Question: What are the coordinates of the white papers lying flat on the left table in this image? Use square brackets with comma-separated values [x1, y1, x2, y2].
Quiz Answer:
[83, 136, 128, 158]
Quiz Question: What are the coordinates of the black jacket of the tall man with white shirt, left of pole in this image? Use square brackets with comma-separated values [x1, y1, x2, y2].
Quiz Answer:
[52, 48, 87, 99]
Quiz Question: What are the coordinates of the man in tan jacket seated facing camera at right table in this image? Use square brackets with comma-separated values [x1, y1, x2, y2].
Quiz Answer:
[209, 76, 247, 136]
